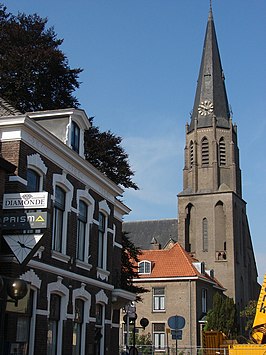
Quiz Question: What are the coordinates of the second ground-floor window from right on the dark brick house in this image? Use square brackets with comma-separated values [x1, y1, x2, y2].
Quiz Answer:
[72, 298, 84, 355]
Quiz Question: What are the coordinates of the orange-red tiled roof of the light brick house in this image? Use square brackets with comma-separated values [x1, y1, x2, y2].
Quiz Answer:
[136, 243, 200, 278]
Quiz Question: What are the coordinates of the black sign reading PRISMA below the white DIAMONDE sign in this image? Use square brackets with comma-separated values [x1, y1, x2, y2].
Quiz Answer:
[0, 211, 47, 229]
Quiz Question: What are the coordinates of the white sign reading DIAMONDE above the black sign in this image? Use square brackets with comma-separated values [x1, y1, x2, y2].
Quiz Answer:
[3, 191, 48, 210]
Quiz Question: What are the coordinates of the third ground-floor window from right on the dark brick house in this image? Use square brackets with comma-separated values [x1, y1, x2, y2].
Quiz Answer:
[47, 293, 61, 355]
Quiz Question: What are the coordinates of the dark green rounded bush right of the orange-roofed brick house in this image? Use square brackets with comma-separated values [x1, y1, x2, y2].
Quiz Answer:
[204, 293, 237, 339]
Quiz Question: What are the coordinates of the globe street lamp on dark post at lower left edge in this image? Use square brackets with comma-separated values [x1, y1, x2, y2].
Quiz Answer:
[0, 275, 28, 354]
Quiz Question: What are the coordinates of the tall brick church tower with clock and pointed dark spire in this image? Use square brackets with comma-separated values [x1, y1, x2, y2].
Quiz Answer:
[178, 7, 258, 309]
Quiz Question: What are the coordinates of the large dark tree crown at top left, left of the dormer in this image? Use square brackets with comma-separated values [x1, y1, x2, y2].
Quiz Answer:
[0, 5, 82, 113]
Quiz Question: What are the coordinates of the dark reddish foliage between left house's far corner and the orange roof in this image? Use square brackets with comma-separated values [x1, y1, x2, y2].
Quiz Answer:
[121, 232, 147, 301]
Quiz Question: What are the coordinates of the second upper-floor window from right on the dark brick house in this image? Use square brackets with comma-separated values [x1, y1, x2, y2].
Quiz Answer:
[77, 201, 88, 261]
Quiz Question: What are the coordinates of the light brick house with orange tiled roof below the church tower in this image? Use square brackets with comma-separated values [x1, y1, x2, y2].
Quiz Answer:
[121, 242, 224, 354]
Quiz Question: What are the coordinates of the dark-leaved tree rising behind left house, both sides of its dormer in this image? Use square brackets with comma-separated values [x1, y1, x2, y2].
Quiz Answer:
[0, 5, 138, 189]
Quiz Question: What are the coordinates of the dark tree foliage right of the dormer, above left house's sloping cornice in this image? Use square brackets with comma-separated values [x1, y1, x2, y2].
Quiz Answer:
[85, 118, 138, 190]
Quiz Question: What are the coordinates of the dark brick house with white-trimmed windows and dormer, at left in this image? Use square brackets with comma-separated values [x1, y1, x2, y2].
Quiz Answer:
[0, 100, 135, 355]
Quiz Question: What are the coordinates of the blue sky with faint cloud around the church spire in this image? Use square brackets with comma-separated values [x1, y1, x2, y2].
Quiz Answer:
[2, 0, 266, 281]
